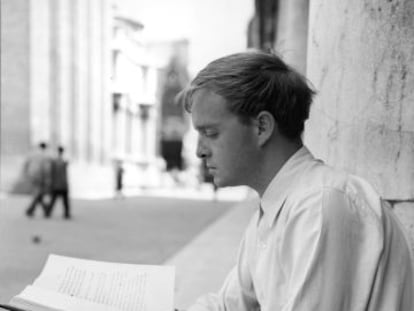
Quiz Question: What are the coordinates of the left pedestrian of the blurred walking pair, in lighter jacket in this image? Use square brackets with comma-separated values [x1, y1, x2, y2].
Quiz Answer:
[24, 142, 51, 217]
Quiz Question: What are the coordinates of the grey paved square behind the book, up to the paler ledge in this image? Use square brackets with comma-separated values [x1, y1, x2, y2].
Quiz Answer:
[0, 197, 238, 302]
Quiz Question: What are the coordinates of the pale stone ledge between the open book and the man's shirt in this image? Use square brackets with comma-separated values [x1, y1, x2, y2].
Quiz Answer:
[165, 199, 255, 310]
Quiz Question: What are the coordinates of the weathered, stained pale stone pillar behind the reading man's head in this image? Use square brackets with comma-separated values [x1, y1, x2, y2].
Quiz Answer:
[305, 0, 414, 200]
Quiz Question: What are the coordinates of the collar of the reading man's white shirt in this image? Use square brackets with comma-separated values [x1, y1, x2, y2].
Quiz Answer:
[260, 146, 315, 227]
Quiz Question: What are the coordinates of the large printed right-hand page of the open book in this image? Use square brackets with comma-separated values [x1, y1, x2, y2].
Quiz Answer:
[25, 255, 174, 311]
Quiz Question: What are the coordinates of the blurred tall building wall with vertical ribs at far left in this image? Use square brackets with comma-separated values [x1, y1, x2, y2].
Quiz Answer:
[1, 0, 112, 192]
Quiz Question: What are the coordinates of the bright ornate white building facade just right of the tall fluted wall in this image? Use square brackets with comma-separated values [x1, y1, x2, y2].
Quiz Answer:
[111, 10, 165, 187]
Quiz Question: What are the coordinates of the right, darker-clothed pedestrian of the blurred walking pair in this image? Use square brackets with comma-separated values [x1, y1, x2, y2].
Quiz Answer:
[47, 146, 71, 219]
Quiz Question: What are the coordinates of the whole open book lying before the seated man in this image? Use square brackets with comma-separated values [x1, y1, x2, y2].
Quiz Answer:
[9, 255, 175, 311]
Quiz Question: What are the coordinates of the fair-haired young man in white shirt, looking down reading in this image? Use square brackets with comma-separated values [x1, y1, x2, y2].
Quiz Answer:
[183, 52, 414, 311]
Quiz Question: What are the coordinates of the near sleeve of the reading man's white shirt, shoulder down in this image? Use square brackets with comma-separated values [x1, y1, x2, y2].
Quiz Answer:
[278, 189, 382, 311]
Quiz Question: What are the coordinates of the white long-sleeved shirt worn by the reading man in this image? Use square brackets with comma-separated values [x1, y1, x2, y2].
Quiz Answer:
[189, 147, 414, 311]
